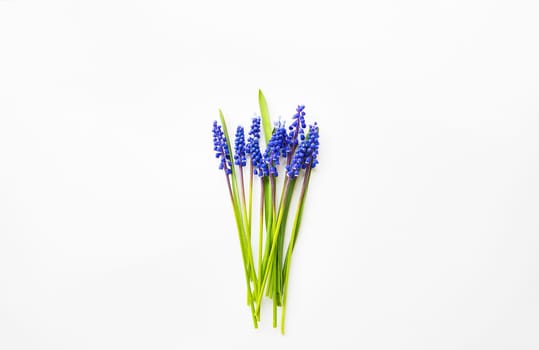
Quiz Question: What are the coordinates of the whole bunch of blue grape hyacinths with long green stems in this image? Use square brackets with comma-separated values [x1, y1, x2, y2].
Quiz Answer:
[213, 91, 319, 334]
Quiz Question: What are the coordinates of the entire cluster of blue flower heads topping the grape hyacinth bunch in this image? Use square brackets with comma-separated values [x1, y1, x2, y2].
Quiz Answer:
[213, 105, 319, 178]
